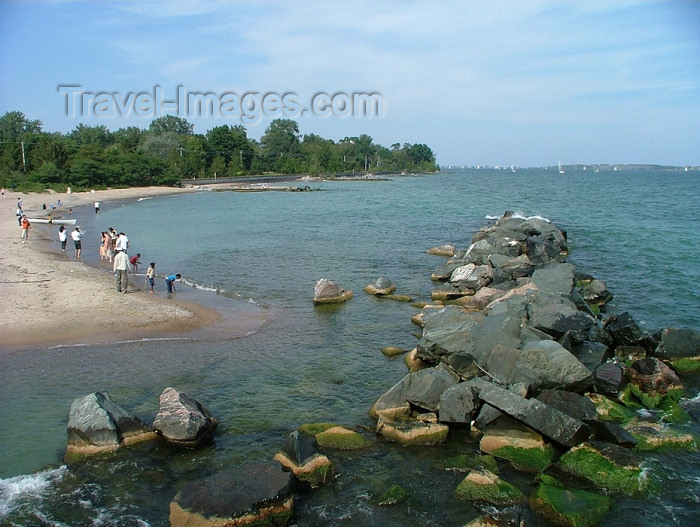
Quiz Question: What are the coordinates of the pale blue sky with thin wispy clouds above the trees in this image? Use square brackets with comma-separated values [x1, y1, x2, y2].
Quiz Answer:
[0, 0, 700, 166]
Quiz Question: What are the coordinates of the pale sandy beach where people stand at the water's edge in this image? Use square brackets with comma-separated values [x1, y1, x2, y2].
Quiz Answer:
[0, 187, 261, 351]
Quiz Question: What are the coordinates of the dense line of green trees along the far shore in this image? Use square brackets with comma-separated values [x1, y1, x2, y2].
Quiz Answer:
[0, 111, 438, 191]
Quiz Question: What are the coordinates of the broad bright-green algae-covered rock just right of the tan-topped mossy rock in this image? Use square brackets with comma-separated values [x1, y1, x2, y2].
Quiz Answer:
[553, 441, 652, 496]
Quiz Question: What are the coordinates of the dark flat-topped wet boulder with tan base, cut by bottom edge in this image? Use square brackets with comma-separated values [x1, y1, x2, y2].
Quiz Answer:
[170, 461, 294, 527]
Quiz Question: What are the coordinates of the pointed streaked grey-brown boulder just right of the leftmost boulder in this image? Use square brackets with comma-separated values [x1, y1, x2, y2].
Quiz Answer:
[153, 387, 218, 447]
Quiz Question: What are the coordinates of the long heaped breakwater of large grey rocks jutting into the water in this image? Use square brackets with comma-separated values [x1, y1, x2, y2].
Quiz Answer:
[370, 213, 700, 526]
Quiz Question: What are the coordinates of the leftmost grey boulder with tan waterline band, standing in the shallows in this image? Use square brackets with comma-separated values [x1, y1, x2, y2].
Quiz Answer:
[66, 392, 156, 461]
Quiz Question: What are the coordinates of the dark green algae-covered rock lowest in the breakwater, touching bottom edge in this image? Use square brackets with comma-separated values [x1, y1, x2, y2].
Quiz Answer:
[530, 474, 613, 527]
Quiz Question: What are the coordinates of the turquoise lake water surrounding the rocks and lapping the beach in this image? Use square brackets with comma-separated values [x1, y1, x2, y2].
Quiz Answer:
[0, 170, 700, 527]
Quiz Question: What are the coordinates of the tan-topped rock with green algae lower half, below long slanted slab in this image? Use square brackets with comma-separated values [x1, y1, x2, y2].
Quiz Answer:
[479, 418, 559, 472]
